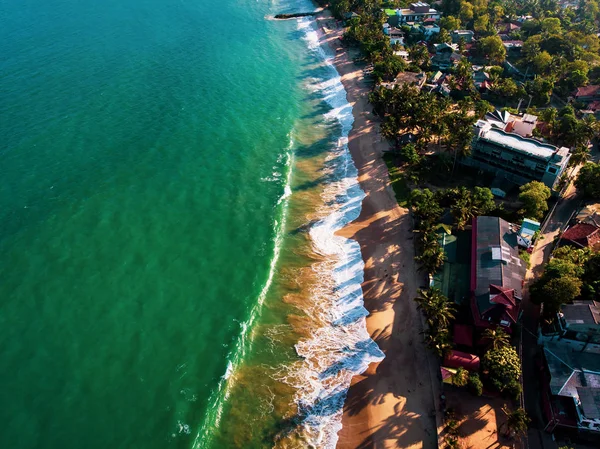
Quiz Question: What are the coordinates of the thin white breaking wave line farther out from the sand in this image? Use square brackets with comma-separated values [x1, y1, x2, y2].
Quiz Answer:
[192, 136, 294, 449]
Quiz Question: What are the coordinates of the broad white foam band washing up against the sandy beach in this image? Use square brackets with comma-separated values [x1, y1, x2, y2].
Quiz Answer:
[282, 18, 384, 449]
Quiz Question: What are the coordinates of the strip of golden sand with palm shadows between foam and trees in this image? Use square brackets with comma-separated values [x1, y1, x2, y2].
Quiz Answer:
[317, 12, 439, 449]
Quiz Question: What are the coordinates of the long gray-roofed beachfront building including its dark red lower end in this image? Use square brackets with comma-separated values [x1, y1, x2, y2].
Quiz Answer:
[470, 216, 526, 332]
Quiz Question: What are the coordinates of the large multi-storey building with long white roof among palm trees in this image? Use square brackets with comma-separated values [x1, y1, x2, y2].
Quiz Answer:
[461, 120, 571, 189]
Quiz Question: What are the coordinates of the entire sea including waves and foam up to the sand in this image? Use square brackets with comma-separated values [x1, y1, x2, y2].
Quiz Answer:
[0, 0, 380, 449]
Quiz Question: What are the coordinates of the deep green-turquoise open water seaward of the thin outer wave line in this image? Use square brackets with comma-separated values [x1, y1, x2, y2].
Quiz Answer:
[0, 0, 305, 449]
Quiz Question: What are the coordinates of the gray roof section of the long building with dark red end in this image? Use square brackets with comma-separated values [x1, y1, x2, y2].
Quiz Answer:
[475, 217, 526, 300]
